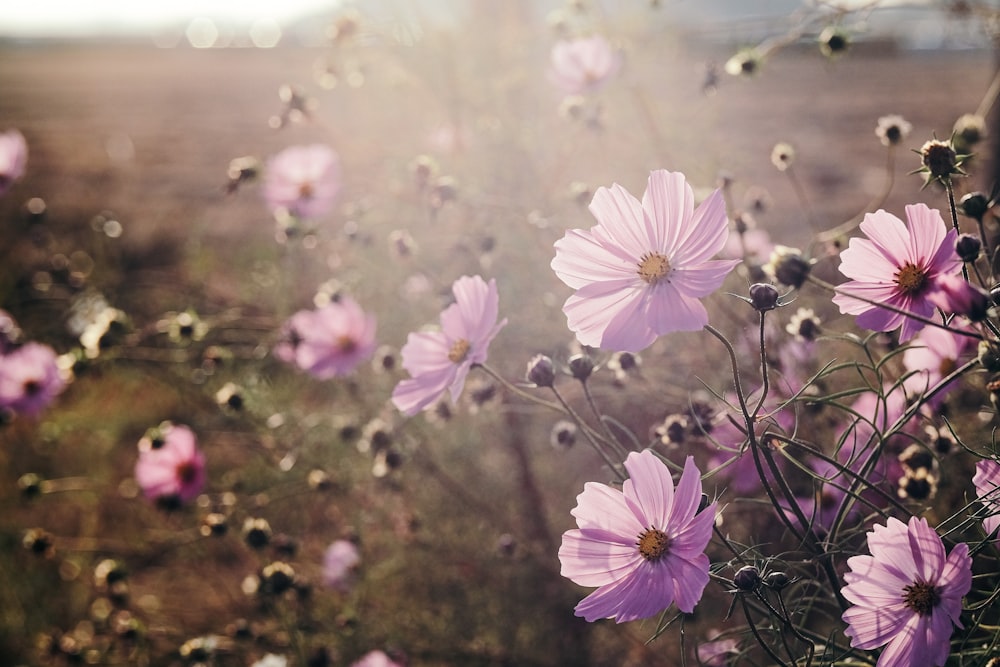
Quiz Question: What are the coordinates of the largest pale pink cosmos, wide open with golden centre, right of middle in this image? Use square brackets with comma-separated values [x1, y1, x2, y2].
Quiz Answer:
[552, 170, 739, 352]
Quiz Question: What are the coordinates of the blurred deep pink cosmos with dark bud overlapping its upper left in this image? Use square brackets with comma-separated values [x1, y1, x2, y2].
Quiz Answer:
[135, 422, 205, 502]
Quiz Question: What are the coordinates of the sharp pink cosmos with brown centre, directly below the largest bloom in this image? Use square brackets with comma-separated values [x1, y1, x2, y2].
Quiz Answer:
[559, 450, 715, 623]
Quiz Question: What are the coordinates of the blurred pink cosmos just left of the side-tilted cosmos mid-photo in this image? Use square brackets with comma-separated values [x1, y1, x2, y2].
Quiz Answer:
[274, 297, 375, 380]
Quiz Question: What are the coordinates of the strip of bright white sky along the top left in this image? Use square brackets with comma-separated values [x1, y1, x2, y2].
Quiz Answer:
[0, 0, 341, 37]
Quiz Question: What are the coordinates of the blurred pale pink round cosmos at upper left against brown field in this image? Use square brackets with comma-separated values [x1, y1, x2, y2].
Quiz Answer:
[264, 144, 340, 218]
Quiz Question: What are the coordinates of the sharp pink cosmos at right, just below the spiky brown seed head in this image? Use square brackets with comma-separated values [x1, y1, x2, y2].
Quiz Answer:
[833, 204, 962, 342]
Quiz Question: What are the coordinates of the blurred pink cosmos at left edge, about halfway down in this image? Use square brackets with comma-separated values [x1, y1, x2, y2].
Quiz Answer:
[0, 342, 66, 416]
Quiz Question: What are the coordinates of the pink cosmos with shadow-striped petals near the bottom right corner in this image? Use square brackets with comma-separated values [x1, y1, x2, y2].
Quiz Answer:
[841, 517, 972, 667]
